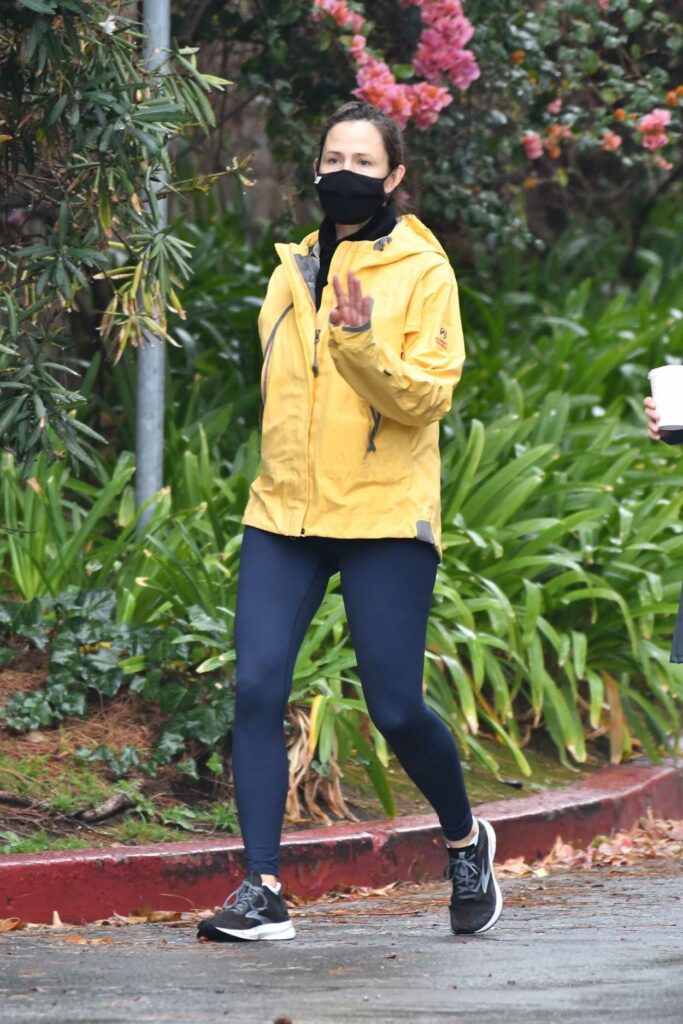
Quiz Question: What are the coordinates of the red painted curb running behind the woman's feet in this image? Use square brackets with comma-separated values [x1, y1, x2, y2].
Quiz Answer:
[0, 764, 683, 923]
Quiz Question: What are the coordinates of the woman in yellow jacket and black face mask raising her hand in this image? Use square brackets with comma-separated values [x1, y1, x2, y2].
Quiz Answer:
[199, 102, 501, 941]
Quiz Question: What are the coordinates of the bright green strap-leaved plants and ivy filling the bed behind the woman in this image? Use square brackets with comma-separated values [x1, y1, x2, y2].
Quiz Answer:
[0, 208, 683, 798]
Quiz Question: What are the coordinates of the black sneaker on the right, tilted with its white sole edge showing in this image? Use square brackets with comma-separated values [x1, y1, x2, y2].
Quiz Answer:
[447, 818, 503, 935]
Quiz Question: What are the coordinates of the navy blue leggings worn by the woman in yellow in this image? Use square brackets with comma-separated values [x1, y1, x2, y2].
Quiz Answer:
[232, 526, 472, 874]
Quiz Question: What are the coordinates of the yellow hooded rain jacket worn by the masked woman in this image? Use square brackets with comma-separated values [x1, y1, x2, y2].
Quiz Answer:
[243, 215, 465, 555]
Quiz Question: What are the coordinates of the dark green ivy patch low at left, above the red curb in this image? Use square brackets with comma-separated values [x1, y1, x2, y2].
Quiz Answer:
[0, 590, 233, 777]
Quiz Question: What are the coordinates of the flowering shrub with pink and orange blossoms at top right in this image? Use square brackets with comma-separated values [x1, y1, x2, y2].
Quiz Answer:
[312, 0, 683, 246]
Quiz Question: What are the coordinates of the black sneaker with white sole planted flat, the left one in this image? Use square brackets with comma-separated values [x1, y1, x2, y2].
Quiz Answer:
[197, 871, 296, 942]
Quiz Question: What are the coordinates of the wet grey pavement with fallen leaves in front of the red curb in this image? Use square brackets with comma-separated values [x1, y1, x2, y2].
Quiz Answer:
[0, 861, 683, 1024]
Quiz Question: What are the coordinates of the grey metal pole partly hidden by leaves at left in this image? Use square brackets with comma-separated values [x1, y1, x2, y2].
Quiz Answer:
[135, 0, 171, 528]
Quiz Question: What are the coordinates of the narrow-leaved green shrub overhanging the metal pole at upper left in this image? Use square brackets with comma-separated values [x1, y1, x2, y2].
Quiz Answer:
[0, 0, 233, 470]
